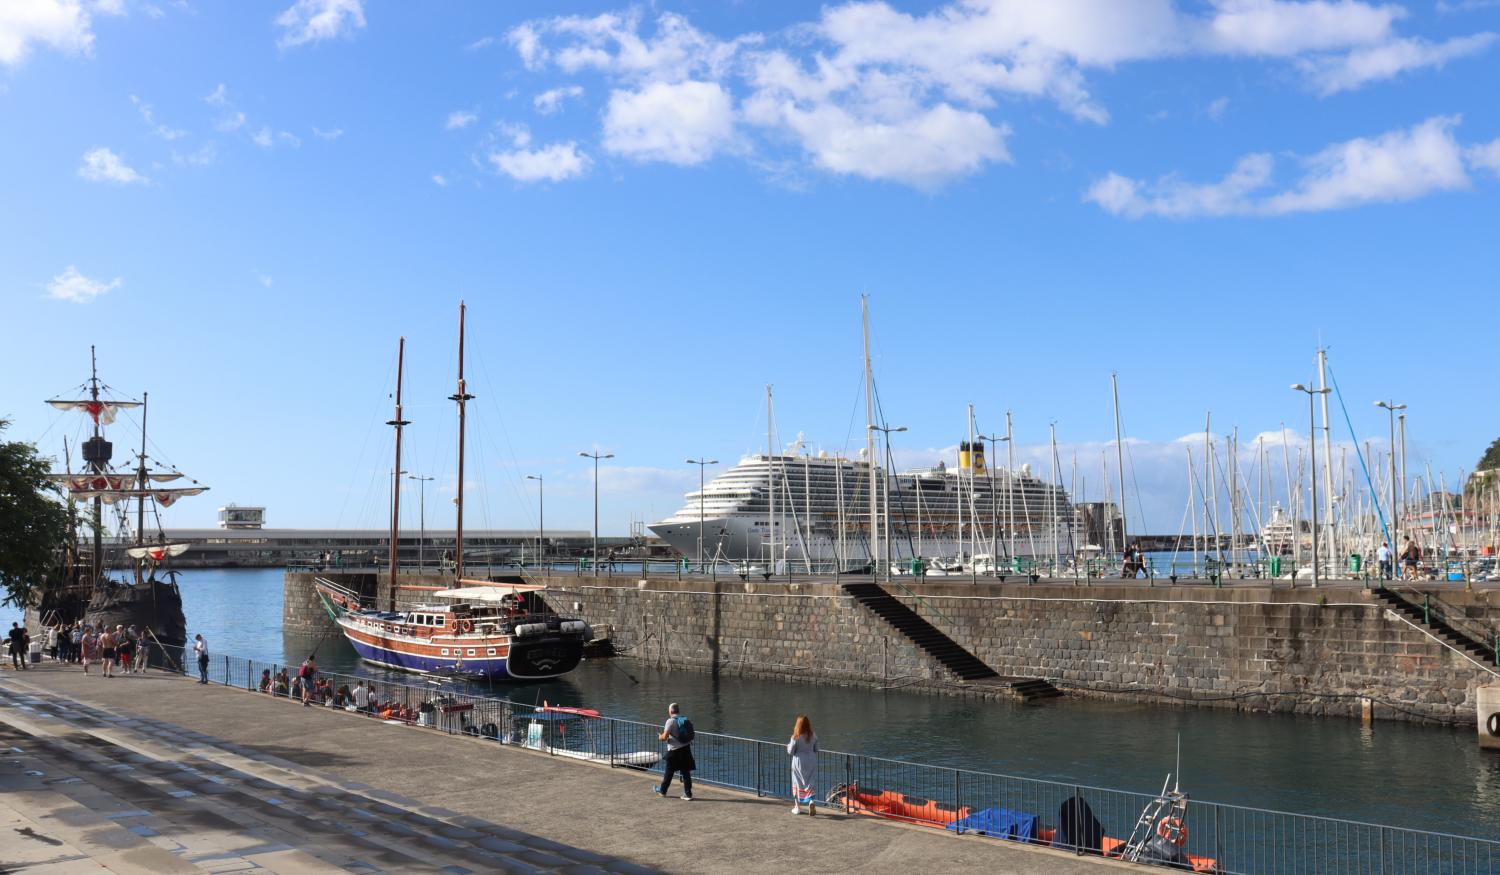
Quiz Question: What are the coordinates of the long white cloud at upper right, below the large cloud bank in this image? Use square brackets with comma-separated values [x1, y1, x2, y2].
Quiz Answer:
[1085, 116, 1469, 219]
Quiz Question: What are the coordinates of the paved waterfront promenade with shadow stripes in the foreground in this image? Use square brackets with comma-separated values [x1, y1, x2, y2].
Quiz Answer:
[0, 663, 1142, 875]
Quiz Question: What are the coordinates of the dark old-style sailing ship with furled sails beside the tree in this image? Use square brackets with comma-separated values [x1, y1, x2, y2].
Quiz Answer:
[30, 348, 209, 647]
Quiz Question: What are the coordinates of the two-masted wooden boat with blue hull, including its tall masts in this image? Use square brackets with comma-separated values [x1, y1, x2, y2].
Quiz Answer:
[315, 303, 593, 680]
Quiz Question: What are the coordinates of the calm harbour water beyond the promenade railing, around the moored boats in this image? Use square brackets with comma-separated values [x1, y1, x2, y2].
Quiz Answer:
[0, 570, 1500, 837]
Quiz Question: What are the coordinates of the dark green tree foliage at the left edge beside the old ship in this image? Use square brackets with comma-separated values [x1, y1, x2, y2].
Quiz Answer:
[0, 419, 68, 605]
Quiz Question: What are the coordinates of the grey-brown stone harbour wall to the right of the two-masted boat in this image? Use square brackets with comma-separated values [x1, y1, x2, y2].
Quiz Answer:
[546, 576, 1500, 723]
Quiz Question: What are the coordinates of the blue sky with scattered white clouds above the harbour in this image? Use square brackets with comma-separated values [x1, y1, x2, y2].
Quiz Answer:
[0, 0, 1500, 533]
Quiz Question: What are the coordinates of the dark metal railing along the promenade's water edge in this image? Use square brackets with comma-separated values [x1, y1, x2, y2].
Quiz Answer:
[152, 647, 1500, 875]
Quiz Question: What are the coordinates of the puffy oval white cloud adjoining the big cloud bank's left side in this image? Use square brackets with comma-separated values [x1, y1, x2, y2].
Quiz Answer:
[605, 81, 734, 165]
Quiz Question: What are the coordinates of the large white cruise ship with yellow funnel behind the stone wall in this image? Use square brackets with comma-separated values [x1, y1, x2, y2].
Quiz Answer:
[650, 441, 1082, 572]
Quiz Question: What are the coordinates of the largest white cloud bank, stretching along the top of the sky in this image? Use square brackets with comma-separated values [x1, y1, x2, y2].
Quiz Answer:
[506, 0, 1494, 188]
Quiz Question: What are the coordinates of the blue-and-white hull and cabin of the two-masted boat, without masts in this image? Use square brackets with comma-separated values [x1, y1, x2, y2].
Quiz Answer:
[315, 578, 593, 680]
